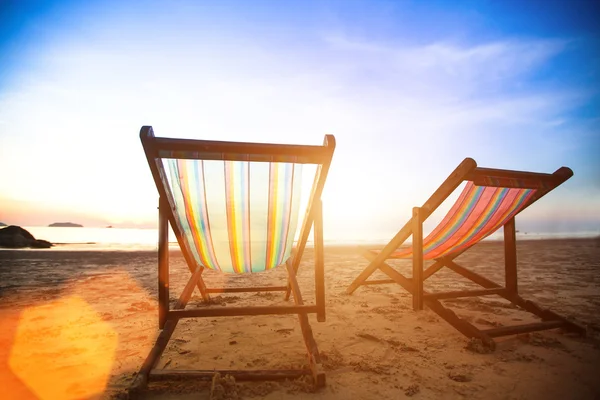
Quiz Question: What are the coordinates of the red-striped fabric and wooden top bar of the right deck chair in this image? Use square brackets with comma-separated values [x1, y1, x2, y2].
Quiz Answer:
[394, 159, 573, 260]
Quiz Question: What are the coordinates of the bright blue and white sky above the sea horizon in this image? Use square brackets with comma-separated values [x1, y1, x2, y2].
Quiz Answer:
[0, 0, 600, 239]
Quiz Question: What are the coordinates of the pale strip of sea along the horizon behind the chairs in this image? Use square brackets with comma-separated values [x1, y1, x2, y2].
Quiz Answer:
[2, 226, 600, 251]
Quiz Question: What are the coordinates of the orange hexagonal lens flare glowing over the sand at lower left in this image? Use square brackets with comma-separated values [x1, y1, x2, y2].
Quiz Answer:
[5, 296, 118, 399]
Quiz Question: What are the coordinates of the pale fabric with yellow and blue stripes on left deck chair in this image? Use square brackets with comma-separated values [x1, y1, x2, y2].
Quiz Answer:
[163, 159, 302, 274]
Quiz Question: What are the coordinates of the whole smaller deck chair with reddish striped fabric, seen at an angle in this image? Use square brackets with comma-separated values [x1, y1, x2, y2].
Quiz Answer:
[347, 158, 585, 349]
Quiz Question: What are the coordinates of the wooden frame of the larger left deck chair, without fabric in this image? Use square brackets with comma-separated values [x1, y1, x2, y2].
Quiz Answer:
[131, 126, 335, 391]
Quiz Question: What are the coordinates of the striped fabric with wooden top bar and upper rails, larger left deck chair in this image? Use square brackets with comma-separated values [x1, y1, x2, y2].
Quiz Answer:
[140, 127, 335, 274]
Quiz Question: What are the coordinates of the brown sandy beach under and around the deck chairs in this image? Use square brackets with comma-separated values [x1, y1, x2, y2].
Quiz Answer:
[0, 239, 600, 399]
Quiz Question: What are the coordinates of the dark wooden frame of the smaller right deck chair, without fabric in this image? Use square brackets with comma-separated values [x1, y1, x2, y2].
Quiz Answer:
[346, 158, 585, 349]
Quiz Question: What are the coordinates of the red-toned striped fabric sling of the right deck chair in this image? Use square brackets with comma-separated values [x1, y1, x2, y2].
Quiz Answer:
[390, 182, 536, 260]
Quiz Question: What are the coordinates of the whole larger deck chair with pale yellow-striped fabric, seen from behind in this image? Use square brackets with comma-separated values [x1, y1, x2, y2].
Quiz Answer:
[130, 126, 335, 391]
